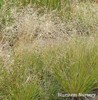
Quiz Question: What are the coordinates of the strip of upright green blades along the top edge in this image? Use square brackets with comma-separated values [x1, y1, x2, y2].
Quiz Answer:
[0, 0, 69, 9]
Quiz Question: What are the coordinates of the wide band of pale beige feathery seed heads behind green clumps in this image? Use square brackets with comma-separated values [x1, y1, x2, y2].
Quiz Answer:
[0, 2, 98, 41]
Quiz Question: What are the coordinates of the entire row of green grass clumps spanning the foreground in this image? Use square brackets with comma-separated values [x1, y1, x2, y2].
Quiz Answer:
[0, 36, 98, 100]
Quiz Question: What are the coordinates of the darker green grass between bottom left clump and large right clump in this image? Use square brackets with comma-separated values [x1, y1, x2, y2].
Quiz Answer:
[13, 49, 61, 100]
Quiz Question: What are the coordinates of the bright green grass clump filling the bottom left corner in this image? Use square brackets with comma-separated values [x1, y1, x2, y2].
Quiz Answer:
[0, 52, 44, 100]
